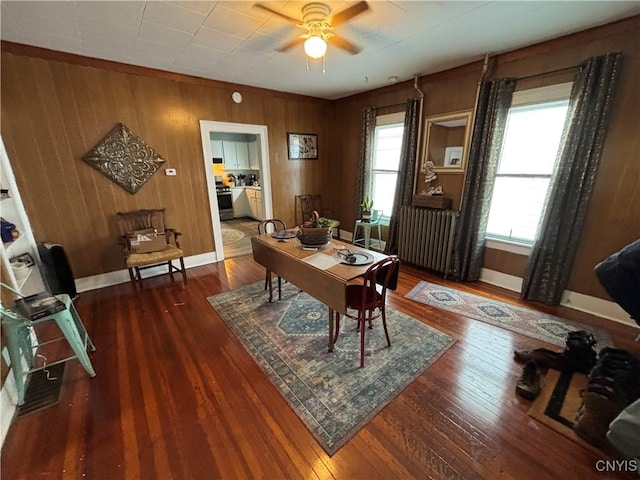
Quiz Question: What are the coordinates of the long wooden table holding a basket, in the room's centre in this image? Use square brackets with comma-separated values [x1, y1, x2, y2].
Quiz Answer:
[251, 233, 387, 352]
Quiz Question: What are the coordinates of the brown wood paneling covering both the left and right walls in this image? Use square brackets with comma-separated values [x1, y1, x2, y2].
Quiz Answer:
[1, 17, 640, 298]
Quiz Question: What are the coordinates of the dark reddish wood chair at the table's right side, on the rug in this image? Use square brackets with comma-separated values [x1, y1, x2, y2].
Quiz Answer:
[333, 256, 400, 367]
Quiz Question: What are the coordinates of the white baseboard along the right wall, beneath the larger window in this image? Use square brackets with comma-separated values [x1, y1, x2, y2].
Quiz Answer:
[480, 268, 640, 328]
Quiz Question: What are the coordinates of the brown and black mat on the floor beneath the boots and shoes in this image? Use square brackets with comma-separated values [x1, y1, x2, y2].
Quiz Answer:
[529, 369, 604, 454]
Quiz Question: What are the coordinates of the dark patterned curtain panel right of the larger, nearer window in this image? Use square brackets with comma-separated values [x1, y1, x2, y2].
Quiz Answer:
[522, 53, 621, 305]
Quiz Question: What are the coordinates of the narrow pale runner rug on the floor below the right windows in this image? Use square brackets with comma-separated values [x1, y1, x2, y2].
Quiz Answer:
[406, 281, 613, 348]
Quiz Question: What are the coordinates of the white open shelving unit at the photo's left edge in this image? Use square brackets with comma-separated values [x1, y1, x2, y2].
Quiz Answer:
[0, 140, 45, 296]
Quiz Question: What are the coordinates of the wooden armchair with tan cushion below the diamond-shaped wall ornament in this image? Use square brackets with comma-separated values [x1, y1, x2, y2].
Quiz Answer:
[116, 208, 187, 285]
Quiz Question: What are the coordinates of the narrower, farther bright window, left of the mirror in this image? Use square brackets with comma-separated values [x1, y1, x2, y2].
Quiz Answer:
[371, 112, 404, 222]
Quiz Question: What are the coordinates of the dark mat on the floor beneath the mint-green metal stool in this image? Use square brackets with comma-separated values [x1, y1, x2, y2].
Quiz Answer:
[16, 362, 65, 418]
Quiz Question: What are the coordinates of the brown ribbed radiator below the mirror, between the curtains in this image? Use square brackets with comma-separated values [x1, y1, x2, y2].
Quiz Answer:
[398, 206, 458, 277]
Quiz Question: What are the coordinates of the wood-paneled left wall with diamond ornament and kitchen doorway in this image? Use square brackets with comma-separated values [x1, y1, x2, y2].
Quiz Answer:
[2, 43, 333, 277]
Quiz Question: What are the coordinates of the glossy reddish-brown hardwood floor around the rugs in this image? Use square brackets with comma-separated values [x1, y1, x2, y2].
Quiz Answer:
[1, 256, 639, 479]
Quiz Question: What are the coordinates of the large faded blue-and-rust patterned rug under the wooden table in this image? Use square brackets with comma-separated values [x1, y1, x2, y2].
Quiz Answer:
[208, 282, 454, 455]
